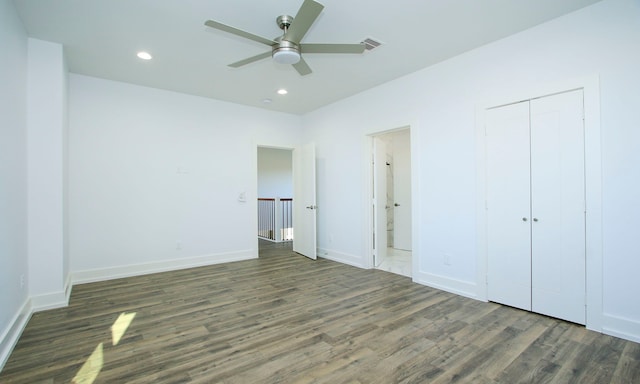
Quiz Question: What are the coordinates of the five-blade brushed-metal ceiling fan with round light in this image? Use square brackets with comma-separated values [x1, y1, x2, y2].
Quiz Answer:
[204, 0, 365, 76]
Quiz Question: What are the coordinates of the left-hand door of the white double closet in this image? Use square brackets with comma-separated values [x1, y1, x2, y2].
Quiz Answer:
[485, 102, 531, 310]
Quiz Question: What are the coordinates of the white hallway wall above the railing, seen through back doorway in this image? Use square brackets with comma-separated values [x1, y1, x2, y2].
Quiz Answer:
[258, 147, 293, 198]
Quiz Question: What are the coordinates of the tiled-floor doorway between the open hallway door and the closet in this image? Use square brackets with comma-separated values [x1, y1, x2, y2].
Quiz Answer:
[371, 128, 412, 277]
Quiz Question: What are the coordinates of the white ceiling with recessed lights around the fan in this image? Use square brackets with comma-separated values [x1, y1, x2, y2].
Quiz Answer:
[14, 0, 598, 114]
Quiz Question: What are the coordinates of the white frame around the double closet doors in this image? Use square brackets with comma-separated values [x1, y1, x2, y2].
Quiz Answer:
[476, 75, 604, 332]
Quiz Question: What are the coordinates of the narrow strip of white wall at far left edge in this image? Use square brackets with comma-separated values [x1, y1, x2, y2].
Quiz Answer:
[0, 0, 28, 369]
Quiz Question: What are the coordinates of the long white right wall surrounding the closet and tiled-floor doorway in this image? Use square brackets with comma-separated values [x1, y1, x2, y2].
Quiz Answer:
[303, 0, 640, 340]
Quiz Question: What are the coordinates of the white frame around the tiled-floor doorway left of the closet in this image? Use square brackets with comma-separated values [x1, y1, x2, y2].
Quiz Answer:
[362, 127, 420, 281]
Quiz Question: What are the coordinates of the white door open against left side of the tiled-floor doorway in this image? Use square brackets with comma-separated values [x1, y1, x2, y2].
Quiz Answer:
[373, 137, 387, 267]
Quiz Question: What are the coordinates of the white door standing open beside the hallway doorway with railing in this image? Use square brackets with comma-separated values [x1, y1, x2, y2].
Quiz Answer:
[293, 144, 317, 260]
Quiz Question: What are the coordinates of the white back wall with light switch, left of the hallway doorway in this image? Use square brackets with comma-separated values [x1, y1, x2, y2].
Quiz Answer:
[69, 75, 300, 281]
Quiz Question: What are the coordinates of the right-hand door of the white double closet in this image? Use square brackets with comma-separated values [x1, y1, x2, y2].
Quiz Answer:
[531, 90, 586, 324]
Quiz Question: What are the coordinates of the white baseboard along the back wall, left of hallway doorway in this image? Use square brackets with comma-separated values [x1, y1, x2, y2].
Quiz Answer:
[71, 249, 257, 284]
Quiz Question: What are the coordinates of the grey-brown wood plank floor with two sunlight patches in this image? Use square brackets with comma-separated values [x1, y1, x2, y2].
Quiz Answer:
[0, 243, 640, 384]
